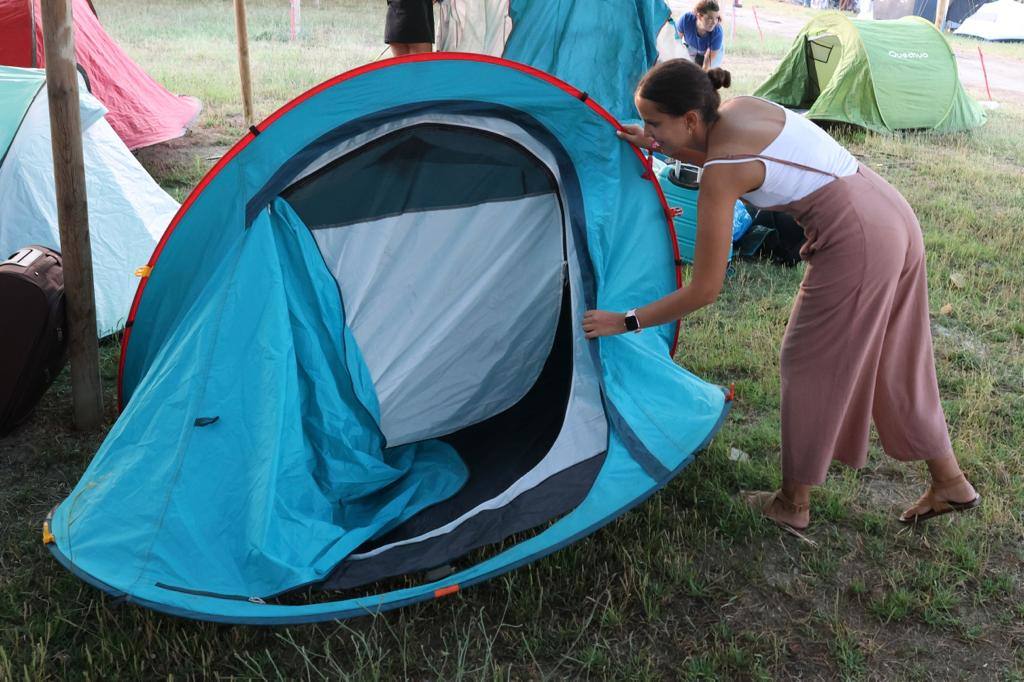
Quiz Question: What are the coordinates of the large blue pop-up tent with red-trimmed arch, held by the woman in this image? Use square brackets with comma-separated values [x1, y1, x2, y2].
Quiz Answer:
[44, 54, 728, 624]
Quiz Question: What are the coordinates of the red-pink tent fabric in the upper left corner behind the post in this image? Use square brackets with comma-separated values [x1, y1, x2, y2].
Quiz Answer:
[0, 0, 202, 150]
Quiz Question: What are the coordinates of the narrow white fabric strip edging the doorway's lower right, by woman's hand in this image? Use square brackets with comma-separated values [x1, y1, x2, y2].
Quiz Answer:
[349, 200, 608, 560]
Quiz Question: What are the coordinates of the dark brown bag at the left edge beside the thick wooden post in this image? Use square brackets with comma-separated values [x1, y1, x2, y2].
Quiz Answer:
[0, 246, 68, 435]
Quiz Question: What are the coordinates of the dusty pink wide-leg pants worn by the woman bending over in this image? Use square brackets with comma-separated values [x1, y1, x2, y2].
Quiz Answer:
[776, 165, 952, 485]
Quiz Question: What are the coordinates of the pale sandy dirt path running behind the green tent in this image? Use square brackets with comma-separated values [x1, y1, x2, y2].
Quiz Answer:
[667, 0, 1024, 103]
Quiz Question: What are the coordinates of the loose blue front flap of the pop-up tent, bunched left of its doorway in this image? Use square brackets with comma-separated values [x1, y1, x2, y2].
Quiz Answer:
[52, 195, 467, 595]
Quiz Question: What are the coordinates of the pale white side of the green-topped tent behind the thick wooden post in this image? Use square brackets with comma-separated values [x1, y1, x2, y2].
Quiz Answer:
[0, 88, 178, 337]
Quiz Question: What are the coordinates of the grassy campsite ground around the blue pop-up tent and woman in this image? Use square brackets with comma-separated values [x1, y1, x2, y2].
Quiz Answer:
[0, 0, 1024, 680]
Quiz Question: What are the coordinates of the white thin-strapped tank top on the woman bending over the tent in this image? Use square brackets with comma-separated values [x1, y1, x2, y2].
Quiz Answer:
[705, 97, 858, 208]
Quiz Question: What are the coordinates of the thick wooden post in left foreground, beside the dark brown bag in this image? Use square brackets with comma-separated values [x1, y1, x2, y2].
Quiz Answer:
[42, 0, 103, 430]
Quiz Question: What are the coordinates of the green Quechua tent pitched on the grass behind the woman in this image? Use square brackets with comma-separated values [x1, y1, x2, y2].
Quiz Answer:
[755, 13, 985, 132]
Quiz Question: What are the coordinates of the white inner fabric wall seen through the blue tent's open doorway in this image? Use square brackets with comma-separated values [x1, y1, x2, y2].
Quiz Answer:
[313, 194, 563, 445]
